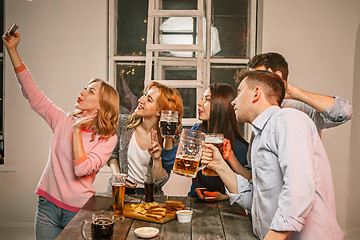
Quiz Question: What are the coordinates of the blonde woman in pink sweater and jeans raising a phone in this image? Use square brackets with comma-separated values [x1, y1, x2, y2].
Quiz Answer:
[3, 34, 119, 240]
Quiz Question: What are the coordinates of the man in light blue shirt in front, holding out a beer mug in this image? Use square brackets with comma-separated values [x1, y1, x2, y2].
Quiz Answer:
[201, 71, 343, 240]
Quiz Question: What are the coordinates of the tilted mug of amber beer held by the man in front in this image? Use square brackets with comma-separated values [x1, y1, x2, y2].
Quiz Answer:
[173, 129, 205, 178]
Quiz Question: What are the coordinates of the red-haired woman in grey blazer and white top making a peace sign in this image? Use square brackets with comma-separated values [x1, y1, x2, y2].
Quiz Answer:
[108, 82, 184, 194]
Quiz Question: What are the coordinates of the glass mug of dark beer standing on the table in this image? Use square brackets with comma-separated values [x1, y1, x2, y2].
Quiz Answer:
[81, 211, 115, 240]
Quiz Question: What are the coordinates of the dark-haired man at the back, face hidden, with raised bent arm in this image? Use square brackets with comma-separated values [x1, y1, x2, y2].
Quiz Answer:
[248, 52, 353, 134]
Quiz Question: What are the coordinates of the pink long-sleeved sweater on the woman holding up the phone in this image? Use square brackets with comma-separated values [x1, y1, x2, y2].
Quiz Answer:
[15, 64, 117, 212]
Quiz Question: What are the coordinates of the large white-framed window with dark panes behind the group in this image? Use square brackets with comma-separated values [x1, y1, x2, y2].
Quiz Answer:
[109, 0, 257, 137]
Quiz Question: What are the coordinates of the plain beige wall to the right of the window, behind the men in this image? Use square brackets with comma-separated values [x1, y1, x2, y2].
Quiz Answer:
[262, 0, 360, 239]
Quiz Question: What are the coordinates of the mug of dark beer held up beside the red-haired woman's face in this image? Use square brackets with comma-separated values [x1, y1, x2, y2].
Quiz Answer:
[160, 110, 179, 138]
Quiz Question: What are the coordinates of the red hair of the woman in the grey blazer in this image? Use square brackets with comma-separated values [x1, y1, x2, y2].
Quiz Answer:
[126, 82, 184, 142]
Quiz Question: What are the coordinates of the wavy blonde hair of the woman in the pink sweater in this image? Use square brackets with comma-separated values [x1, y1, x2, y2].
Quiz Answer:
[72, 78, 120, 141]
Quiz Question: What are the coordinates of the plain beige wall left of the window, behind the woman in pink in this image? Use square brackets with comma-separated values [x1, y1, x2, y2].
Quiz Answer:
[0, 0, 107, 227]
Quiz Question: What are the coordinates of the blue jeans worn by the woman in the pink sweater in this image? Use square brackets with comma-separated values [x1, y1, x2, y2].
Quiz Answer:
[35, 196, 76, 240]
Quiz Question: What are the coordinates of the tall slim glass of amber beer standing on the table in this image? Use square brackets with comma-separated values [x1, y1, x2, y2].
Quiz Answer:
[111, 173, 126, 220]
